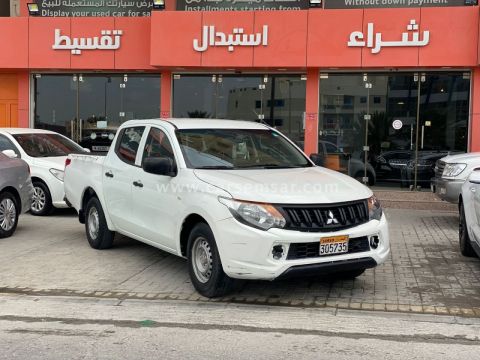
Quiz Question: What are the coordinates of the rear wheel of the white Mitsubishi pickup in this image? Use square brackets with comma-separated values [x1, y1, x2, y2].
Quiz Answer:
[85, 197, 115, 250]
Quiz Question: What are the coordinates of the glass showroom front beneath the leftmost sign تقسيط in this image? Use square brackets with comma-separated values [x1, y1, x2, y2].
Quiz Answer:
[33, 74, 160, 151]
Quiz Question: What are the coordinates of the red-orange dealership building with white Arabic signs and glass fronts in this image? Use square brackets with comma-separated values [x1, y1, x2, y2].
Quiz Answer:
[0, 0, 480, 188]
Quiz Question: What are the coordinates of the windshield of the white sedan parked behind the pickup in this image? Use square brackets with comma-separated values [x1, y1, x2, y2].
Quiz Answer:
[13, 133, 85, 157]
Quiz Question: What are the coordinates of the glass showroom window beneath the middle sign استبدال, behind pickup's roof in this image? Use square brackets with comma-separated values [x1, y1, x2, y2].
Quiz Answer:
[173, 74, 306, 147]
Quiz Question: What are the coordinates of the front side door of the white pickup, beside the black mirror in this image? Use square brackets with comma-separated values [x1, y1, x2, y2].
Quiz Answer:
[132, 126, 181, 251]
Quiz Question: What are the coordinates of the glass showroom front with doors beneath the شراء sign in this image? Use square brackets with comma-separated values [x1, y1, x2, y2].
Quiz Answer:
[318, 72, 470, 188]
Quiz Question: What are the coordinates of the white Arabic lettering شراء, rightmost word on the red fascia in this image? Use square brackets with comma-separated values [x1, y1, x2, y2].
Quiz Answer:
[348, 19, 430, 54]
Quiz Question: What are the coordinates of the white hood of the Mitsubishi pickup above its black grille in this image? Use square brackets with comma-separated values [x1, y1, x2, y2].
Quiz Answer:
[194, 167, 372, 204]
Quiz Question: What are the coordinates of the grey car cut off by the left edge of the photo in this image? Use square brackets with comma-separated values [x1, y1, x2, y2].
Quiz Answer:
[0, 150, 33, 238]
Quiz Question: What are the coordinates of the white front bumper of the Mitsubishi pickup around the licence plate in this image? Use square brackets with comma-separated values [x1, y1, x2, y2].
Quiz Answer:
[213, 214, 390, 280]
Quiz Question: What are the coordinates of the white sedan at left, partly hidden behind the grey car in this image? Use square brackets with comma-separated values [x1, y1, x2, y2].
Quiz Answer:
[0, 128, 85, 215]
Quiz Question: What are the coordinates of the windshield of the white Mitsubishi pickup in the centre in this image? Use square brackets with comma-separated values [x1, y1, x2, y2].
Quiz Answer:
[177, 129, 312, 169]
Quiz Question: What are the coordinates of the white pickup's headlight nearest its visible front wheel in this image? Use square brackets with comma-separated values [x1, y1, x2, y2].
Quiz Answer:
[218, 196, 286, 230]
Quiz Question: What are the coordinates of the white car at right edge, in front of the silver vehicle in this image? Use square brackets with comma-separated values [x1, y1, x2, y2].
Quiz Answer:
[458, 170, 480, 256]
